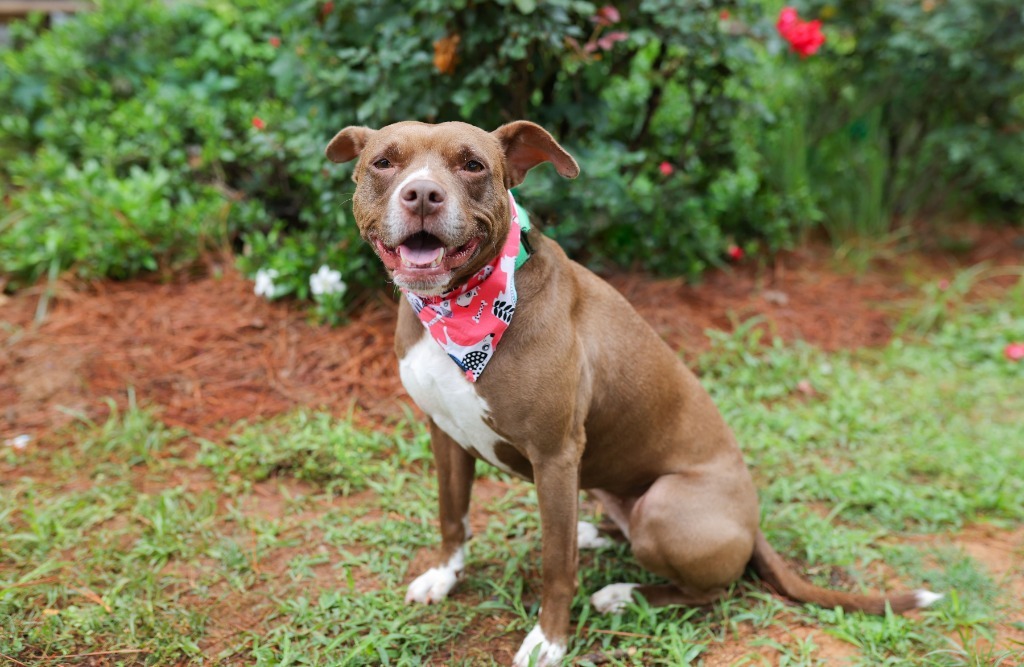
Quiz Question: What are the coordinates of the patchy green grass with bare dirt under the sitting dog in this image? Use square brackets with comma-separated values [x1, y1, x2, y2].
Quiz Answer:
[0, 289, 1024, 666]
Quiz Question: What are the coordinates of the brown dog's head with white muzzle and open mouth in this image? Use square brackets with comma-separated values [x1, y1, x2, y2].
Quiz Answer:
[327, 121, 580, 295]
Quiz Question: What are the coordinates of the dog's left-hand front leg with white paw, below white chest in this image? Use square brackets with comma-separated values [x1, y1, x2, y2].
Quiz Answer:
[406, 421, 476, 605]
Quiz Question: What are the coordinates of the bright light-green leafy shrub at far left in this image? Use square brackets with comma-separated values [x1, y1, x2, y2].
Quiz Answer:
[0, 1, 284, 287]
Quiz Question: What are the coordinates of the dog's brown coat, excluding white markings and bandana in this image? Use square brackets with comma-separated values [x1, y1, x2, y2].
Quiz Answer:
[328, 121, 937, 663]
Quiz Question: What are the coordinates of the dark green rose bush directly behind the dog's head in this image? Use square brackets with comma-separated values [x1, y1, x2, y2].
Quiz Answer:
[271, 0, 813, 276]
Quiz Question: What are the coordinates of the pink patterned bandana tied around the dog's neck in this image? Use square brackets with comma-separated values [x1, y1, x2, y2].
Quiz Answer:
[402, 193, 520, 382]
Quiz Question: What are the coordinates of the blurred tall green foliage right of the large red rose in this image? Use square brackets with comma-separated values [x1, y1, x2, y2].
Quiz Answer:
[770, 0, 1024, 239]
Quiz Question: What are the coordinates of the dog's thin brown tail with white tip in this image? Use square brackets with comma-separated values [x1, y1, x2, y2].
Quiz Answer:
[751, 531, 942, 615]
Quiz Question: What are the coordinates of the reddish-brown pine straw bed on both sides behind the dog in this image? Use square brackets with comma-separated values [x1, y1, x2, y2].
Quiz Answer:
[0, 226, 1024, 439]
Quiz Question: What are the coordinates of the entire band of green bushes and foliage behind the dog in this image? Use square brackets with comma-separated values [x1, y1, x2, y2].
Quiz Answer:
[0, 0, 1024, 309]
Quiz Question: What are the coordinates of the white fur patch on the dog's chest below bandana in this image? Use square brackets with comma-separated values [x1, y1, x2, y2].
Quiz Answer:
[398, 331, 515, 474]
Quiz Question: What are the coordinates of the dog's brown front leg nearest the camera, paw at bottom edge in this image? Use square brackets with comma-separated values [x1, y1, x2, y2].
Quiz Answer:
[513, 443, 580, 667]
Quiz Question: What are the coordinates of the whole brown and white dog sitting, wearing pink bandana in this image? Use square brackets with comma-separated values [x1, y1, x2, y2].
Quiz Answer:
[327, 121, 939, 665]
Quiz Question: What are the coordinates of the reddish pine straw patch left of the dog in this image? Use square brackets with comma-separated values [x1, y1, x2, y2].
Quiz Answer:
[0, 270, 401, 437]
